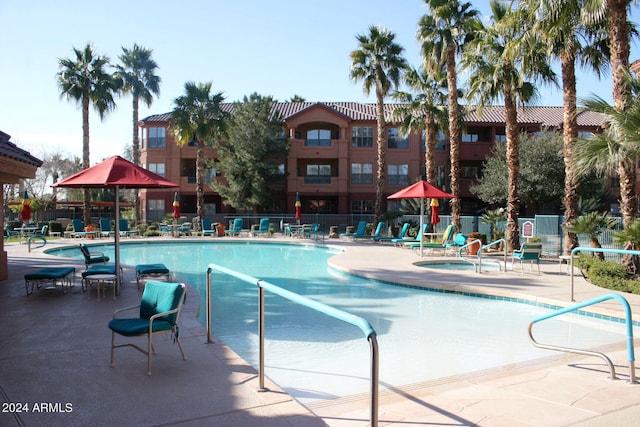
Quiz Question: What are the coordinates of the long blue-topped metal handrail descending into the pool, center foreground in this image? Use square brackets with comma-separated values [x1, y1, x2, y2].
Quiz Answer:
[206, 264, 380, 426]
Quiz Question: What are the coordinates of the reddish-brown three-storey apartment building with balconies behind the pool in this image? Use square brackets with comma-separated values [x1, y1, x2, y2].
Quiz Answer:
[140, 102, 603, 221]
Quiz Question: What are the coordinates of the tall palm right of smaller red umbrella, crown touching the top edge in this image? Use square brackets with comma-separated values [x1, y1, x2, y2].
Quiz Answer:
[417, 0, 480, 230]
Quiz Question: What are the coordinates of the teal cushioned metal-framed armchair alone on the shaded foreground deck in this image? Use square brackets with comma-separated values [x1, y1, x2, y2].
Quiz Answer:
[109, 281, 187, 375]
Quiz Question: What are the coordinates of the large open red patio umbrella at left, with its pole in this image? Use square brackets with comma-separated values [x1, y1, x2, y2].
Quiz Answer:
[52, 156, 179, 286]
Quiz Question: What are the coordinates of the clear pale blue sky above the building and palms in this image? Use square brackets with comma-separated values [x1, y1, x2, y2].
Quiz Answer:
[0, 0, 640, 163]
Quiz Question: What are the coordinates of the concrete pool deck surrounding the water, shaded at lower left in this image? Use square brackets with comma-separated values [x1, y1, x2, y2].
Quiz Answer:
[0, 237, 640, 427]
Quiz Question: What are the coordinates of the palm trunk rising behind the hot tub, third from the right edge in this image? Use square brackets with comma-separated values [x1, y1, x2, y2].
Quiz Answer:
[503, 73, 520, 251]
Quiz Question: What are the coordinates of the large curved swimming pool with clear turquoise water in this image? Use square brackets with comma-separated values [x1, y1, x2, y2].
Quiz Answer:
[51, 241, 637, 402]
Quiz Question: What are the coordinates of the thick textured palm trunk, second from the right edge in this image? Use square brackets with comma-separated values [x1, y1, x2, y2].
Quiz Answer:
[561, 54, 578, 255]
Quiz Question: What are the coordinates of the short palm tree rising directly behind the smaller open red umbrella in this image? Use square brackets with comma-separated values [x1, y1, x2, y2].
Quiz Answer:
[393, 67, 449, 185]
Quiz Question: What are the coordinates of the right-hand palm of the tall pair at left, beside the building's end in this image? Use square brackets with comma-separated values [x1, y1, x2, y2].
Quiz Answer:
[116, 44, 161, 220]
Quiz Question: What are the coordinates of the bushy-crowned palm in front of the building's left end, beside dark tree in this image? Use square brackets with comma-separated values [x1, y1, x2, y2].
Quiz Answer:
[169, 82, 229, 218]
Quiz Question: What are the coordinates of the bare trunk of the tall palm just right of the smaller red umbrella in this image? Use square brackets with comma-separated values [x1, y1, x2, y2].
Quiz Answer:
[447, 45, 462, 230]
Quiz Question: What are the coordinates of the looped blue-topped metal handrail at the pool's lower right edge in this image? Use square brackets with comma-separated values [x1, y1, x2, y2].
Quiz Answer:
[529, 294, 636, 384]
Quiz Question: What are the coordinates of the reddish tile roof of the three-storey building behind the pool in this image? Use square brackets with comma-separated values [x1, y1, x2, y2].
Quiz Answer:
[142, 102, 604, 128]
